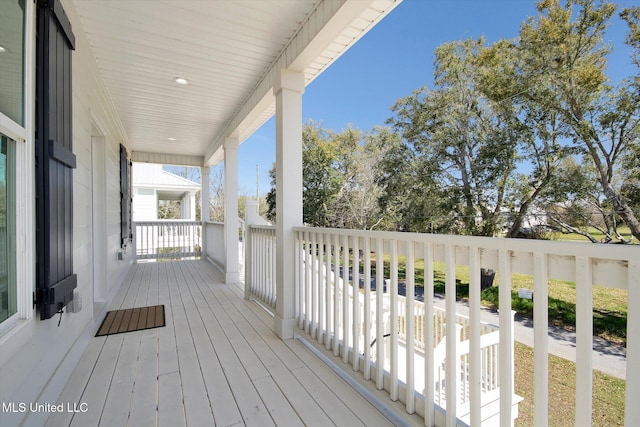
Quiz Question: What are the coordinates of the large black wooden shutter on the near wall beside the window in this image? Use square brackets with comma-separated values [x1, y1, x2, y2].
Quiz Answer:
[34, 0, 77, 320]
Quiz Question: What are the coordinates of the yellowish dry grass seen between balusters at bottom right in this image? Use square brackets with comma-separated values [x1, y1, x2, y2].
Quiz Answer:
[515, 343, 625, 426]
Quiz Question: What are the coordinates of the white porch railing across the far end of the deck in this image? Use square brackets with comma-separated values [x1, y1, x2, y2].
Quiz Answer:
[133, 220, 202, 259]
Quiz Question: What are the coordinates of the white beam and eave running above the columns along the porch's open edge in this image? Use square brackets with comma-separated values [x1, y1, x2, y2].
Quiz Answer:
[204, 0, 402, 165]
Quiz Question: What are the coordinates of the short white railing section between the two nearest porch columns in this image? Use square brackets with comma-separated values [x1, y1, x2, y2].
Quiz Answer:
[244, 224, 276, 310]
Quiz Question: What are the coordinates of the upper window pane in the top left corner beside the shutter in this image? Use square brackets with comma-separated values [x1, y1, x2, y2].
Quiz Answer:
[0, 0, 24, 126]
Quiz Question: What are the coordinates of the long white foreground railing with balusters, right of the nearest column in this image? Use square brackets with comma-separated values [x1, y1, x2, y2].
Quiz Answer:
[292, 227, 640, 426]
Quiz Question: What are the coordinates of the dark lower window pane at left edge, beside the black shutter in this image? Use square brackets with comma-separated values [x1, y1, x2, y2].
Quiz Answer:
[0, 132, 17, 322]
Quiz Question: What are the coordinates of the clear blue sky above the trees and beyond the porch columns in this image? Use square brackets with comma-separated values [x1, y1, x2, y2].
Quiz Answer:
[238, 0, 640, 195]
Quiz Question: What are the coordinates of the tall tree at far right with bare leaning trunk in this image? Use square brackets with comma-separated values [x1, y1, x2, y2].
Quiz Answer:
[488, 0, 640, 238]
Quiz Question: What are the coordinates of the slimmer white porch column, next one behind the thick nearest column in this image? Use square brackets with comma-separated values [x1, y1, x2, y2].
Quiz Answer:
[224, 138, 240, 283]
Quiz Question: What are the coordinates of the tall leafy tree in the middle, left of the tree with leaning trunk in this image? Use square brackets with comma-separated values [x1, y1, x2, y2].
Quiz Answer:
[389, 39, 522, 236]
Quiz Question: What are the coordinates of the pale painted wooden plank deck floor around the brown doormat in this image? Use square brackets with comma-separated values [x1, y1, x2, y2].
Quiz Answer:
[47, 261, 390, 427]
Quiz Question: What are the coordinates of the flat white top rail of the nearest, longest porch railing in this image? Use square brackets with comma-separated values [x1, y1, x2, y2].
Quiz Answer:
[294, 227, 640, 261]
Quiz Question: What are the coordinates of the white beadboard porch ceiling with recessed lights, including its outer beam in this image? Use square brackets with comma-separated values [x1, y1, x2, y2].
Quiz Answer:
[74, 0, 397, 162]
